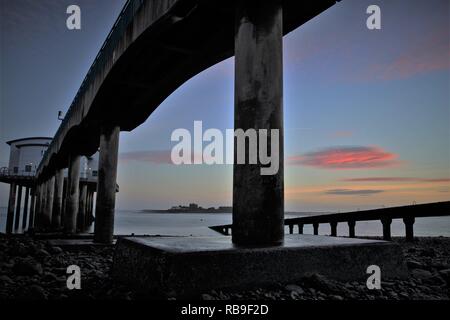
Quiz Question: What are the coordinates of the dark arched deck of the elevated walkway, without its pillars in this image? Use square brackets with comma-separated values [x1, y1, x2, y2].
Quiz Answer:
[38, 0, 335, 175]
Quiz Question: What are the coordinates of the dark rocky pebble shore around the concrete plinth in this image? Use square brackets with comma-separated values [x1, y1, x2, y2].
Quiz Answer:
[0, 235, 450, 300]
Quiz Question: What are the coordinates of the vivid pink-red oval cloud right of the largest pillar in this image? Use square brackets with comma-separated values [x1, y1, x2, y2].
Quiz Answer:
[287, 146, 400, 170]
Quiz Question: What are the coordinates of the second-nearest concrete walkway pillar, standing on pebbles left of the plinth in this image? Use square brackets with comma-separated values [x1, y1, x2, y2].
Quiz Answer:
[94, 126, 120, 243]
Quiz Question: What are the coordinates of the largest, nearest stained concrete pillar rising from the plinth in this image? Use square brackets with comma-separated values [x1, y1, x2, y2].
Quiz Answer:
[232, 1, 284, 245]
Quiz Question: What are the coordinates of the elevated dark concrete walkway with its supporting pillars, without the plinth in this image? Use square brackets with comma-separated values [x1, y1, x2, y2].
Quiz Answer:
[32, 0, 335, 245]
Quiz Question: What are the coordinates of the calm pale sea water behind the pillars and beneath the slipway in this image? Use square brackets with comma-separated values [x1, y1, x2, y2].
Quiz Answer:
[0, 207, 450, 237]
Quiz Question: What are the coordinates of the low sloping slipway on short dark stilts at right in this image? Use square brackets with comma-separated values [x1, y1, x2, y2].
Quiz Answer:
[210, 201, 450, 241]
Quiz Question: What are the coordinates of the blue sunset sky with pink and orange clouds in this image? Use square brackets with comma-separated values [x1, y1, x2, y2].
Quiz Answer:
[0, 0, 450, 211]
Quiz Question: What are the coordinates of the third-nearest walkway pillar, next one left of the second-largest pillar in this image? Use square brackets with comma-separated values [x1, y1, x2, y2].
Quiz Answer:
[64, 155, 80, 234]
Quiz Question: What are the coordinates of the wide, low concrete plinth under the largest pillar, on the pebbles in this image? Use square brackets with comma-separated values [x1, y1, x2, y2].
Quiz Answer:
[113, 235, 407, 296]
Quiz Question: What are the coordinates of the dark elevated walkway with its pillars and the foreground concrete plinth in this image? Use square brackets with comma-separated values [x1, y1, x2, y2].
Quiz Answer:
[1, 0, 418, 294]
